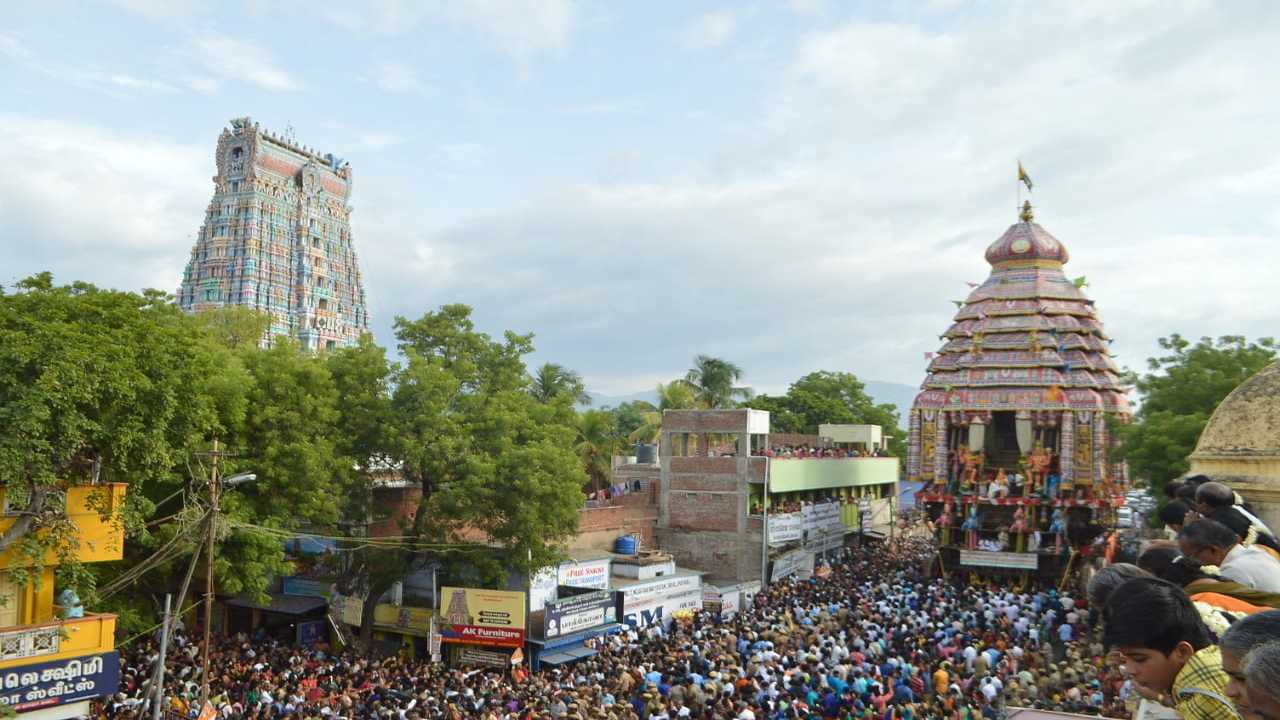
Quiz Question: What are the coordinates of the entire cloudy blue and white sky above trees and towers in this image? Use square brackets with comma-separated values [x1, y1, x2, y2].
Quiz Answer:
[0, 0, 1280, 395]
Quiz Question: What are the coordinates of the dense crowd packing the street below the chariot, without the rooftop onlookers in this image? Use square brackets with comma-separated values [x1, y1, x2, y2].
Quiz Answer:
[101, 537, 1128, 720]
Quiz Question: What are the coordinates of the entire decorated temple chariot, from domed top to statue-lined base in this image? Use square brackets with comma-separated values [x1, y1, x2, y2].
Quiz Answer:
[908, 202, 1129, 582]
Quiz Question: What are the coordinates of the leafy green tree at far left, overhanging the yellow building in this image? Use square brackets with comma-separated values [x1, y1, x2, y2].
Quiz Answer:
[0, 273, 247, 598]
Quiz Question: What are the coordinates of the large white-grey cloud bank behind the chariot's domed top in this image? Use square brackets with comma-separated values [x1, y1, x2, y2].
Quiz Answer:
[366, 4, 1280, 392]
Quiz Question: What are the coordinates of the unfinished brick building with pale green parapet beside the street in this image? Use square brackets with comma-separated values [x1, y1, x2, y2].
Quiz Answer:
[657, 409, 899, 583]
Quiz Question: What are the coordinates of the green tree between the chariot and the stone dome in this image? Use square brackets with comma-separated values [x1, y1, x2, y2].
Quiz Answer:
[1116, 334, 1277, 489]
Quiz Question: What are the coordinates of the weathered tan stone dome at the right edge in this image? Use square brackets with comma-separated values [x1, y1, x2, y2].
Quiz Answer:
[1190, 363, 1280, 528]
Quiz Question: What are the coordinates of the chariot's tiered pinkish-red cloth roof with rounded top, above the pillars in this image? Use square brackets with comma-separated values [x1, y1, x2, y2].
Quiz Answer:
[915, 208, 1129, 414]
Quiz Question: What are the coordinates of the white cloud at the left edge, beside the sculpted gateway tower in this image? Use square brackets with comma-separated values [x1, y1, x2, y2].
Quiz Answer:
[0, 115, 212, 292]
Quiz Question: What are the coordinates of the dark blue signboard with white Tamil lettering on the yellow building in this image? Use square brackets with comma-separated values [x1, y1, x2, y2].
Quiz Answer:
[0, 652, 120, 712]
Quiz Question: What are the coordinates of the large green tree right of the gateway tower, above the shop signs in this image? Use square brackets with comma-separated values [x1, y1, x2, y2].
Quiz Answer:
[343, 305, 588, 642]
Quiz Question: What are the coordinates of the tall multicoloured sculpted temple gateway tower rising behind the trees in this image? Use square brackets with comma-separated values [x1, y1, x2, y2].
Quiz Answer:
[178, 118, 369, 350]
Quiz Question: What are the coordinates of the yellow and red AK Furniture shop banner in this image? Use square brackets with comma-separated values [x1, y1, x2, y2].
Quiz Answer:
[439, 587, 525, 647]
